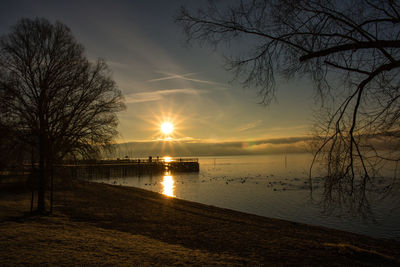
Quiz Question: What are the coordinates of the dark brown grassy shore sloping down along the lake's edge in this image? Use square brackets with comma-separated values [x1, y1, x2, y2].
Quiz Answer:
[0, 182, 400, 266]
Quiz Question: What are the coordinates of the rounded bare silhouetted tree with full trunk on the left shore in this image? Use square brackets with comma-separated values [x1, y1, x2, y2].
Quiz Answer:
[0, 19, 124, 212]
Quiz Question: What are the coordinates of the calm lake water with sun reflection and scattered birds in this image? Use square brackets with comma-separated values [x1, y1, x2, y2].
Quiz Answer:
[95, 154, 400, 240]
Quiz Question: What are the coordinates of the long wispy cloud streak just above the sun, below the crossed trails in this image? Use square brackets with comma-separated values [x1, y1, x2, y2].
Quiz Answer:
[125, 88, 206, 103]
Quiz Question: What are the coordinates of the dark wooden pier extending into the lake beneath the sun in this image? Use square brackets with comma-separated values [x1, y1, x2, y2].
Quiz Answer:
[57, 157, 200, 179]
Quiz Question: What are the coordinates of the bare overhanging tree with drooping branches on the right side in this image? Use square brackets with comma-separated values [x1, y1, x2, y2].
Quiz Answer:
[176, 0, 400, 200]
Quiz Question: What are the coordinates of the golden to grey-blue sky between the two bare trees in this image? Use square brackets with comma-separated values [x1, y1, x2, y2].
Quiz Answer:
[0, 0, 314, 154]
